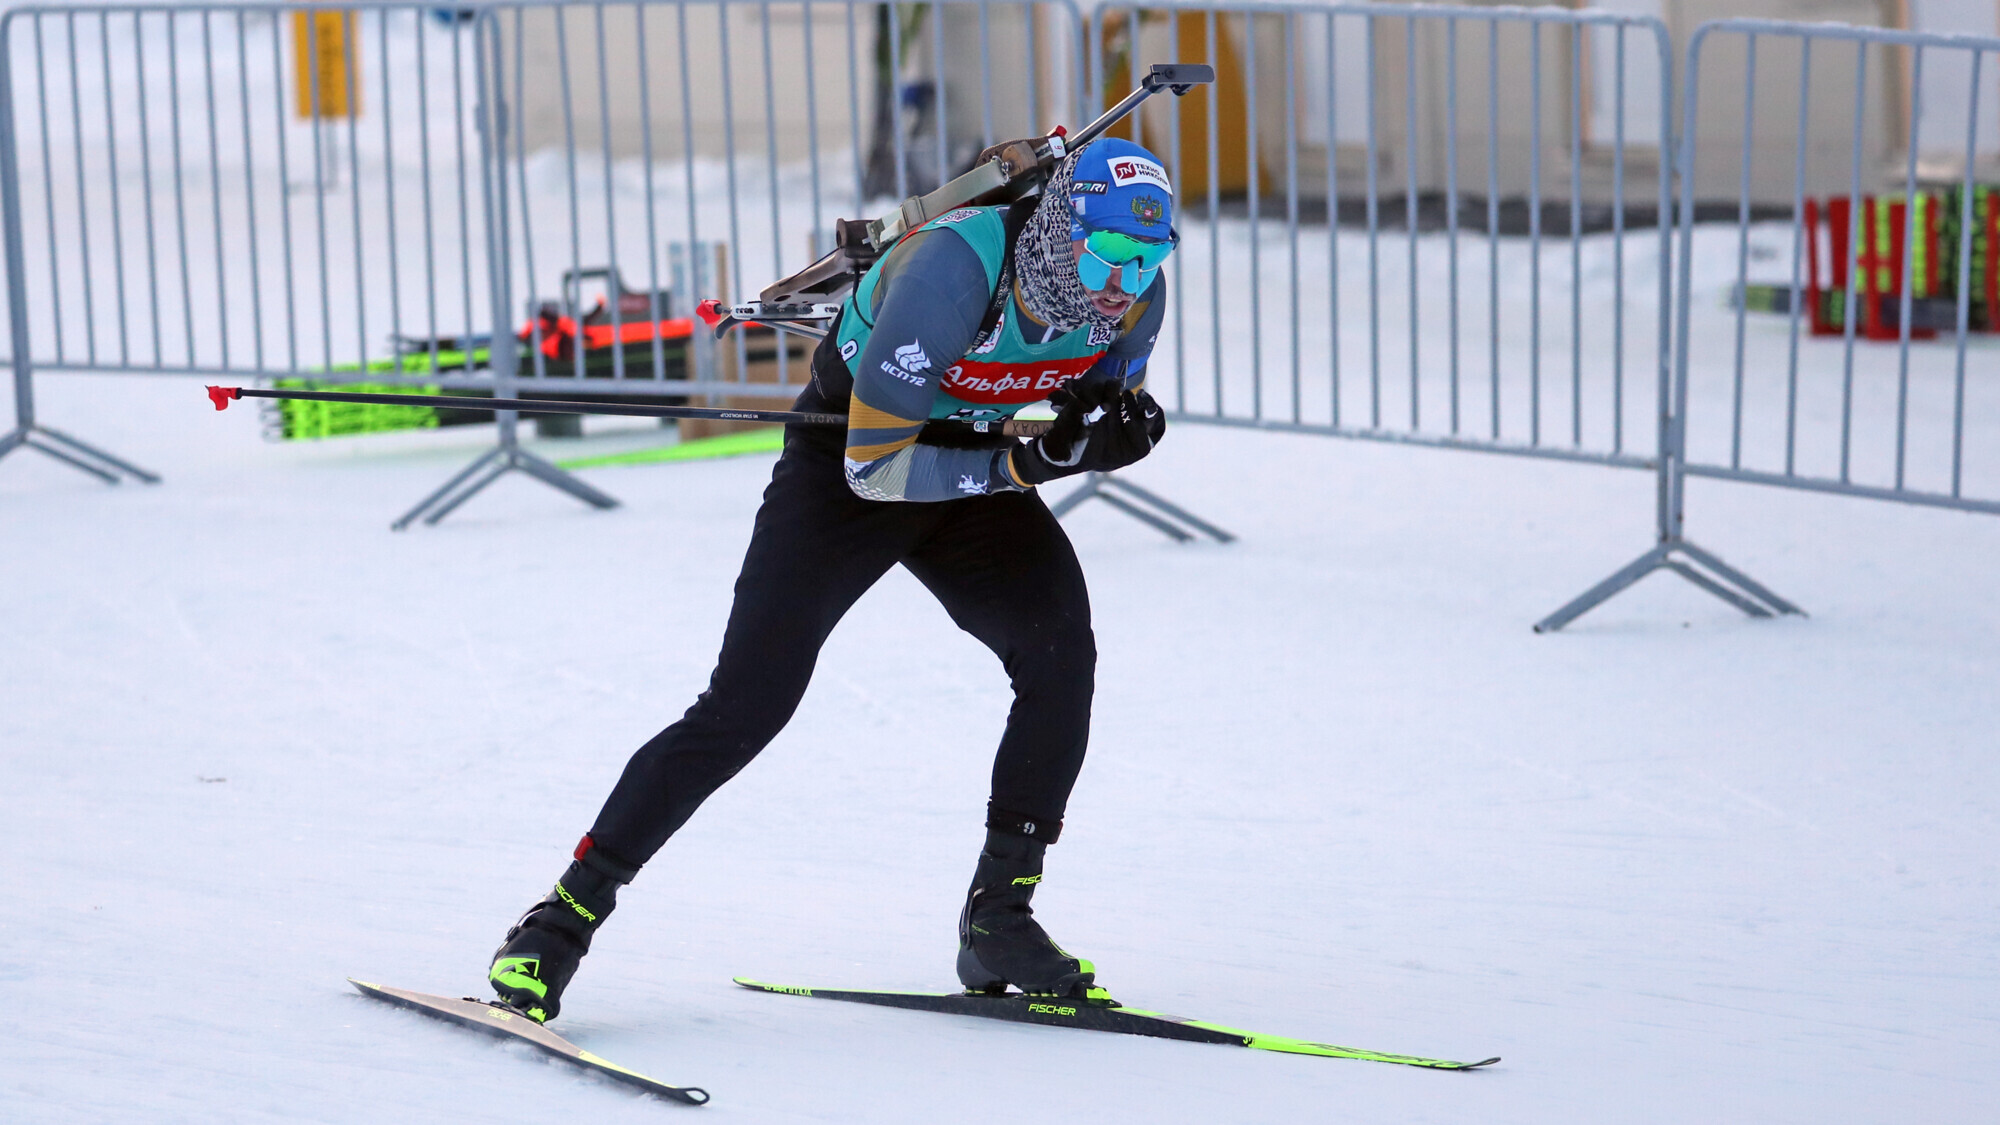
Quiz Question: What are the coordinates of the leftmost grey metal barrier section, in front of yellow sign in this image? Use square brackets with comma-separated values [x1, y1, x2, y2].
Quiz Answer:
[0, 4, 508, 478]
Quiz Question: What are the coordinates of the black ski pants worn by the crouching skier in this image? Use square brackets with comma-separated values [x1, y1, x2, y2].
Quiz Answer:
[590, 430, 1096, 865]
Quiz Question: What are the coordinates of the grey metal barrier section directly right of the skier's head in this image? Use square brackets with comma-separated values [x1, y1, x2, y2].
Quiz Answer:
[1090, 4, 1672, 476]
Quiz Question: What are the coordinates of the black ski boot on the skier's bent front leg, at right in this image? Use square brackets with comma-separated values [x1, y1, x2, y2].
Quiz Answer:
[958, 829, 1102, 999]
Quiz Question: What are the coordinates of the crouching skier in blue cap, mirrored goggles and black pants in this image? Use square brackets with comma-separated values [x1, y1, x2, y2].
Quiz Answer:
[488, 138, 1178, 1021]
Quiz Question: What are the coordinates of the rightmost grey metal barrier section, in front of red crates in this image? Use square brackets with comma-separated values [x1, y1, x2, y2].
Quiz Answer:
[1678, 20, 2000, 512]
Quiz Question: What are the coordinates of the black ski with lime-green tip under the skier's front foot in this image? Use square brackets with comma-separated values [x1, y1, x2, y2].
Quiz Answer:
[736, 977, 1500, 1071]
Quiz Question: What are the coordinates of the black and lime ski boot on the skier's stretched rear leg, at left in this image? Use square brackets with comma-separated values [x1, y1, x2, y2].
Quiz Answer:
[486, 837, 638, 1023]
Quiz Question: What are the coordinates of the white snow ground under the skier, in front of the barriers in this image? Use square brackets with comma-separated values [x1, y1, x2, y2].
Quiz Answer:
[0, 366, 2000, 1123]
